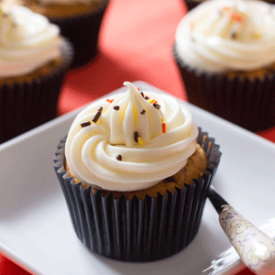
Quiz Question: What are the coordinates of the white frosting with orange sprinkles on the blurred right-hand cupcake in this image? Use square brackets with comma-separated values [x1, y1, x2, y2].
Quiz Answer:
[176, 0, 275, 72]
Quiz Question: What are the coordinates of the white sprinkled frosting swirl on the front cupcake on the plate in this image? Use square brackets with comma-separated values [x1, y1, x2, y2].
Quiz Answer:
[65, 82, 198, 191]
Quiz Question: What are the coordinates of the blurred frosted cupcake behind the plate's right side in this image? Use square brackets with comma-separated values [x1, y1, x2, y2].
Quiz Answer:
[176, 0, 275, 132]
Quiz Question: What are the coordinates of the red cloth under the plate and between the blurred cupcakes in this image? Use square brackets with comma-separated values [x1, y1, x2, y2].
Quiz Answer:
[0, 0, 275, 275]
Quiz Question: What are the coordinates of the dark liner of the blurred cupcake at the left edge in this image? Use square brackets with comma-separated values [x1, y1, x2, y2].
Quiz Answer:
[0, 41, 73, 143]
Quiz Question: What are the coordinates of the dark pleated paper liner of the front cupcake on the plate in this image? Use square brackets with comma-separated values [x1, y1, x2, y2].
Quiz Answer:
[54, 131, 221, 262]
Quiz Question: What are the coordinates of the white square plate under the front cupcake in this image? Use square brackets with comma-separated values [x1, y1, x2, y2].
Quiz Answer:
[0, 81, 275, 275]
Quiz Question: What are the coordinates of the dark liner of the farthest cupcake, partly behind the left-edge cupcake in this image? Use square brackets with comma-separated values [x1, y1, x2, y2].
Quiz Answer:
[49, 0, 109, 68]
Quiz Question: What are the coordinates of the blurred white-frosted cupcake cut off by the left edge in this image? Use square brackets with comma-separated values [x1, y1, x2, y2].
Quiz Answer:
[0, 4, 72, 143]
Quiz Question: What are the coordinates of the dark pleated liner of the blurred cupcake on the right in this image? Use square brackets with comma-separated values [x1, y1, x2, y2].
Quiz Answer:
[173, 46, 275, 132]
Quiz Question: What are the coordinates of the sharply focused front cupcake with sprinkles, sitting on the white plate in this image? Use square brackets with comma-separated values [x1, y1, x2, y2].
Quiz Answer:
[54, 82, 221, 262]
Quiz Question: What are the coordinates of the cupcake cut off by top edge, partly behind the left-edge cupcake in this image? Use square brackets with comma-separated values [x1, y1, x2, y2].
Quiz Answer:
[24, 0, 109, 67]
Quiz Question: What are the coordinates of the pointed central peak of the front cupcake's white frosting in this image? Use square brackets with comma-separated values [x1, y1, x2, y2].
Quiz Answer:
[106, 82, 163, 147]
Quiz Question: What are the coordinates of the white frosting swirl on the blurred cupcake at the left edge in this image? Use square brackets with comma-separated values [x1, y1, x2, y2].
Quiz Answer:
[0, 4, 63, 77]
